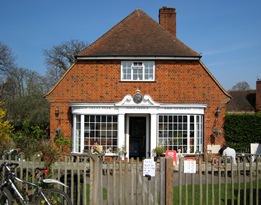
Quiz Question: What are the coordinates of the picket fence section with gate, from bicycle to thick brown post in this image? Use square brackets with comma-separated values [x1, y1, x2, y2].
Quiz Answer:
[0, 153, 173, 205]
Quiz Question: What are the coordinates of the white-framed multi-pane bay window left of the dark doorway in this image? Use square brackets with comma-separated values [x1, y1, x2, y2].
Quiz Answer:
[73, 115, 118, 153]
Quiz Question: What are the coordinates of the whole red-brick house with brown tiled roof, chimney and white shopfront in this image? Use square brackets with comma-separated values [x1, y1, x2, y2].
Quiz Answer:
[46, 7, 230, 158]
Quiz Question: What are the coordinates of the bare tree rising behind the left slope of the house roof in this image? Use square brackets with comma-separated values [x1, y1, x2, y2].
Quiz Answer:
[43, 40, 87, 85]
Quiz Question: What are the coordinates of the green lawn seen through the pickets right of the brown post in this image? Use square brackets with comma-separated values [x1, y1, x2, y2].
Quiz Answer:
[173, 179, 261, 205]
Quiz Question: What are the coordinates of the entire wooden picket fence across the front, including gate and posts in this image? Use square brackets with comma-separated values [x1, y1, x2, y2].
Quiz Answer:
[0, 153, 261, 205]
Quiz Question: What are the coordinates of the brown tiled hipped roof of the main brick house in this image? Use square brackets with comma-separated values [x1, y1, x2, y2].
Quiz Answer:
[78, 9, 201, 57]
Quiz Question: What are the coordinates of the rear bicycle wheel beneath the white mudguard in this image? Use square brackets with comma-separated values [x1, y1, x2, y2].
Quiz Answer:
[36, 189, 72, 205]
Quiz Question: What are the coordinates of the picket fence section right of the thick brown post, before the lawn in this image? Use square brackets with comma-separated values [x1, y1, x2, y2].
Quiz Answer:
[174, 154, 261, 205]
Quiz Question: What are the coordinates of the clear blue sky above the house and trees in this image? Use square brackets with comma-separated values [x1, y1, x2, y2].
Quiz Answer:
[0, 0, 261, 89]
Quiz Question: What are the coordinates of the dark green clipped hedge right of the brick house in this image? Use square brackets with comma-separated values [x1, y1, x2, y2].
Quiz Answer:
[224, 113, 261, 152]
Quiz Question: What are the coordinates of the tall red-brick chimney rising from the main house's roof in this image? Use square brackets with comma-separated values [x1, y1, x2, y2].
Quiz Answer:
[159, 6, 176, 36]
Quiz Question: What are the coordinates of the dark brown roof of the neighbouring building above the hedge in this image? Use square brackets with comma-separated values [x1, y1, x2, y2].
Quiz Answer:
[227, 90, 256, 112]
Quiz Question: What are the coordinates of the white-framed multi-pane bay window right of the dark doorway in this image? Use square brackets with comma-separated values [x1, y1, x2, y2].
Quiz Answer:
[158, 115, 203, 154]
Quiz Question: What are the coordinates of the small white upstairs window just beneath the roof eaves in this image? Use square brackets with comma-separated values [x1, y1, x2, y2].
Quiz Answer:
[121, 61, 155, 81]
